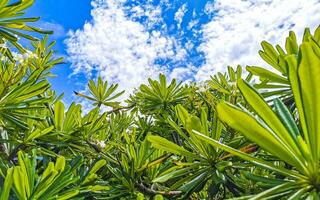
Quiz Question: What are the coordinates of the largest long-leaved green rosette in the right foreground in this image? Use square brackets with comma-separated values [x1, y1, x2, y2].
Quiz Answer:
[208, 36, 320, 198]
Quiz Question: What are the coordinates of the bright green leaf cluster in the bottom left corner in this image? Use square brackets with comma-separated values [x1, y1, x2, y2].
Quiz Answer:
[0, 149, 109, 199]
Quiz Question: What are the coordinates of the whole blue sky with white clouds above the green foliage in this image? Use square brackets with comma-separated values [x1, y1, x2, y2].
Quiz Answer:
[27, 0, 320, 102]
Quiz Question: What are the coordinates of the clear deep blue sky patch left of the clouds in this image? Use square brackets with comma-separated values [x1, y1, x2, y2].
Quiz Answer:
[27, 0, 92, 101]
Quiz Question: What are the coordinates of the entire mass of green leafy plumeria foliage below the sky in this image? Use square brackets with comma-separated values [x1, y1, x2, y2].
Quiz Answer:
[0, 0, 320, 200]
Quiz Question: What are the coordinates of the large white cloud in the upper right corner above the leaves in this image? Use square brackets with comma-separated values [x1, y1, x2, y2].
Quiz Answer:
[195, 0, 320, 80]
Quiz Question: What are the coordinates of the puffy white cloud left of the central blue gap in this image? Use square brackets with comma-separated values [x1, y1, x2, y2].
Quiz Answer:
[66, 0, 179, 98]
